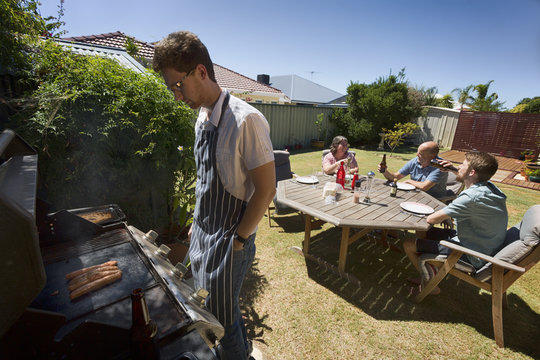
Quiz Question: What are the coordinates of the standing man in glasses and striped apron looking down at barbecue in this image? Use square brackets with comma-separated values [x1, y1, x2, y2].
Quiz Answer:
[153, 31, 275, 359]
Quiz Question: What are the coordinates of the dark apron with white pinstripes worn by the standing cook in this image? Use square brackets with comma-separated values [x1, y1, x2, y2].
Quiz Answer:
[189, 93, 247, 326]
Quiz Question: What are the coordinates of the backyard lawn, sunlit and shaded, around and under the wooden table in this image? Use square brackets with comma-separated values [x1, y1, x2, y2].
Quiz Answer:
[241, 149, 540, 359]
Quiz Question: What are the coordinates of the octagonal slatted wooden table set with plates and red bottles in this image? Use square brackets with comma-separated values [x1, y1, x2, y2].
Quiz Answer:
[277, 175, 445, 271]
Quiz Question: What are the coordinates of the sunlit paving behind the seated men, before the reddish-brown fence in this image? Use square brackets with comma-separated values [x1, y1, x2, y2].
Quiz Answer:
[439, 150, 540, 190]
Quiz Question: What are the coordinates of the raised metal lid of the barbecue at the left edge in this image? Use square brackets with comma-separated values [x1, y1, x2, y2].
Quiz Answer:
[0, 130, 45, 336]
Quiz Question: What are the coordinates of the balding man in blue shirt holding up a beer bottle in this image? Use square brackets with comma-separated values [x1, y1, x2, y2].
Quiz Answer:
[379, 141, 448, 198]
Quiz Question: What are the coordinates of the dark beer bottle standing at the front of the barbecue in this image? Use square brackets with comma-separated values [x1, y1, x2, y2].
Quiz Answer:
[130, 288, 160, 359]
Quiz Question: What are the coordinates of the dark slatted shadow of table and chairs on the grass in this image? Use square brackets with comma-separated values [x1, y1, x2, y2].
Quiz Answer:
[306, 228, 540, 358]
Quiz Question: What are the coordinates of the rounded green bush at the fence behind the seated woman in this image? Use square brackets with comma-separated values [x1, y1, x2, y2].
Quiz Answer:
[331, 69, 422, 144]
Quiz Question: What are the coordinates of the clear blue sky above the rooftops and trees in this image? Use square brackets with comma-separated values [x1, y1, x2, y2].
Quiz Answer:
[41, 0, 540, 108]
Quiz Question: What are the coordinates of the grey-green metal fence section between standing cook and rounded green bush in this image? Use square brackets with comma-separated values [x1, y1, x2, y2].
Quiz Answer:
[251, 103, 333, 149]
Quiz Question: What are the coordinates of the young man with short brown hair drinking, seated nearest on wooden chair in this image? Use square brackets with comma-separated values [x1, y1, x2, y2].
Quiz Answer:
[403, 152, 508, 294]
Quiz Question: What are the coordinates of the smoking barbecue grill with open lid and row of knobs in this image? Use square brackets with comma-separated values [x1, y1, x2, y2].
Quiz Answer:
[0, 130, 224, 359]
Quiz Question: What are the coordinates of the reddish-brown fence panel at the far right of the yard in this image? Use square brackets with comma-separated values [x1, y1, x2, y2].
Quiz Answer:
[452, 111, 540, 158]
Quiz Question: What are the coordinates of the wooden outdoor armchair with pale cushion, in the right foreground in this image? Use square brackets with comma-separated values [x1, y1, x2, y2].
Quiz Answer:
[416, 205, 540, 347]
